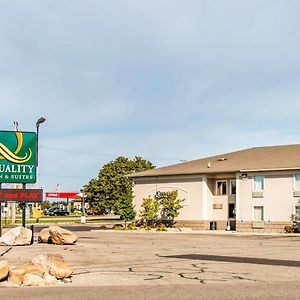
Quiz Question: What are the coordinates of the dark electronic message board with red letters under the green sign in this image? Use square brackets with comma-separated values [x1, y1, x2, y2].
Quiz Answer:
[0, 189, 43, 202]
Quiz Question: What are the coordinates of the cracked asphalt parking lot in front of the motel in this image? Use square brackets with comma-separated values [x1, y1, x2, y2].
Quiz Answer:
[0, 227, 300, 299]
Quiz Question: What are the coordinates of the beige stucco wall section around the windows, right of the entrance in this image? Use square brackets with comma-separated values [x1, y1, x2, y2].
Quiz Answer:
[239, 172, 298, 222]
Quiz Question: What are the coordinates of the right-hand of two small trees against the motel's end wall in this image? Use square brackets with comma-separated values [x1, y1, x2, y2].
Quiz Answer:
[155, 190, 182, 227]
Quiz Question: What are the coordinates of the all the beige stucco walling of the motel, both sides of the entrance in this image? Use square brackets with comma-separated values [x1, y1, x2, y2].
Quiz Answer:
[134, 171, 300, 231]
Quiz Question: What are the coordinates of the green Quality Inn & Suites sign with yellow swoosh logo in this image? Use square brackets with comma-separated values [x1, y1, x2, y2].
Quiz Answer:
[0, 131, 36, 183]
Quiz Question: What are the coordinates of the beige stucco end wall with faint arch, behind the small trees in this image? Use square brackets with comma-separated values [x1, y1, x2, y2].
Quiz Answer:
[133, 176, 203, 220]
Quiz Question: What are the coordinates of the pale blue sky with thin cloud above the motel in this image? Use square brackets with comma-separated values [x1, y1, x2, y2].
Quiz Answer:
[0, 0, 300, 191]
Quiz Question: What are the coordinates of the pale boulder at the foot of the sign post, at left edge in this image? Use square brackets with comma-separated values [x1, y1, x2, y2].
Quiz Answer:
[0, 226, 32, 246]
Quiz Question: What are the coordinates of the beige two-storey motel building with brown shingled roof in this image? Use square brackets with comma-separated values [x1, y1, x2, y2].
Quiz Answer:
[129, 144, 300, 232]
